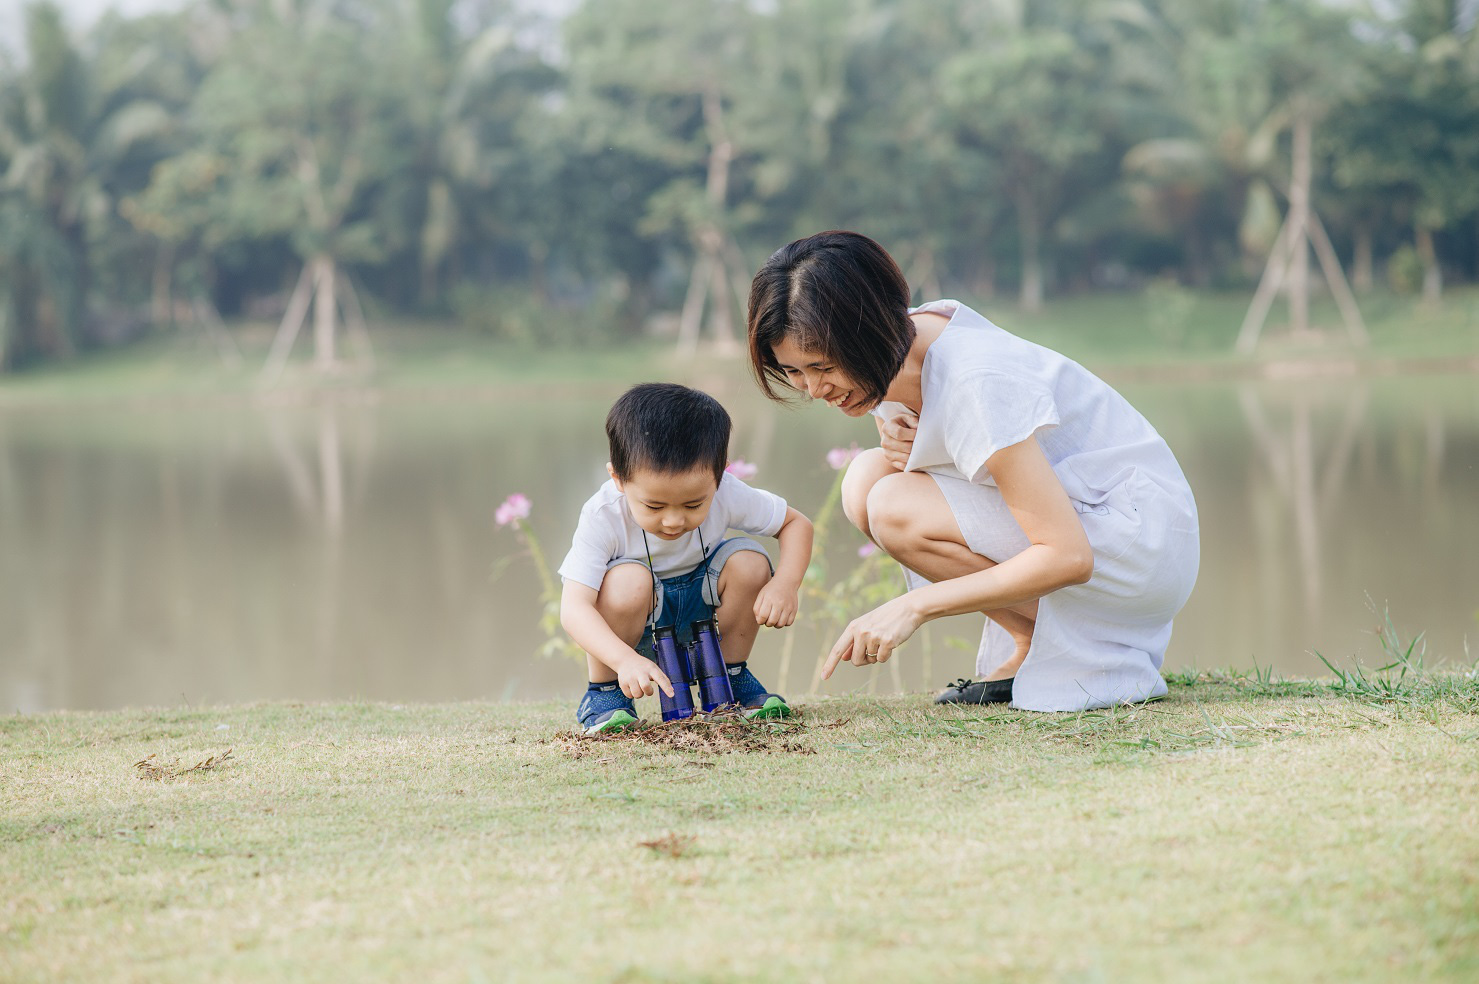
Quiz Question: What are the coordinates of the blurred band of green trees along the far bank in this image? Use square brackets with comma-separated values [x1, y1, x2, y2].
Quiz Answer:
[0, 0, 1479, 370]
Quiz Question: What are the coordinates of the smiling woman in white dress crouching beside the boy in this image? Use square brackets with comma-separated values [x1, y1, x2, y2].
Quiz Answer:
[750, 232, 1199, 710]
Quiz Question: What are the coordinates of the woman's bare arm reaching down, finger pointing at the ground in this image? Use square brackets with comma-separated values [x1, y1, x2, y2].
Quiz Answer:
[822, 438, 1094, 679]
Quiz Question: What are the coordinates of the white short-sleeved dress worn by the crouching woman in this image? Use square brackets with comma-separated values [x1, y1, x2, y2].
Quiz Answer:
[874, 300, 1201, 710]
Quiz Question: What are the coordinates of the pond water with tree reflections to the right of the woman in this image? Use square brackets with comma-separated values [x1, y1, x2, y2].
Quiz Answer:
[1162, 377, 1479, 673]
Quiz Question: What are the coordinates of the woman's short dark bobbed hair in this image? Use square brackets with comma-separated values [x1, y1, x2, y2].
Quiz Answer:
[750, 232, 914, 405]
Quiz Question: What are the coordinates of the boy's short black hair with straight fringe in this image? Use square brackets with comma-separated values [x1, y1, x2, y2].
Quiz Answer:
[606, 383, 731, 482]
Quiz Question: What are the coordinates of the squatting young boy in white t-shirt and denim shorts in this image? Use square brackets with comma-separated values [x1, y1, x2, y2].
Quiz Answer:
[559, 383, 812, 734]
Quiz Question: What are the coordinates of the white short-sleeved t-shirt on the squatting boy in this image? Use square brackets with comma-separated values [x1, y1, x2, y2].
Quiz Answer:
[559, 472, 785, 590]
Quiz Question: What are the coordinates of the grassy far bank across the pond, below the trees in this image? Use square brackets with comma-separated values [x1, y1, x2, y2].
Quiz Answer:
[0, 286, 1479, 408]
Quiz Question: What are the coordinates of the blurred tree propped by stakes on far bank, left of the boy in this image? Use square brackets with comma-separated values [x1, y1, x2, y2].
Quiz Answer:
[181, 0, 416, 376]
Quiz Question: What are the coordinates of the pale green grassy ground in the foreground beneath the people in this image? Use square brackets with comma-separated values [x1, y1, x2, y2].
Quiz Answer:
[0, 673, 1479, 984]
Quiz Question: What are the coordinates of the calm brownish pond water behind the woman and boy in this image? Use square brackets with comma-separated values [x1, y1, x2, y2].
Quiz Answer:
[0, 365, 1479, 713]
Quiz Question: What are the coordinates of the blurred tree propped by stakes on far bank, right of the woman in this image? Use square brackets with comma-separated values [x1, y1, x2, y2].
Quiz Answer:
[1124, 0, 1364, 348]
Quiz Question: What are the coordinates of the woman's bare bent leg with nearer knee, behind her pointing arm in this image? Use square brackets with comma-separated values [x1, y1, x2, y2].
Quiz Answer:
[858, 467, 1037, 679]
